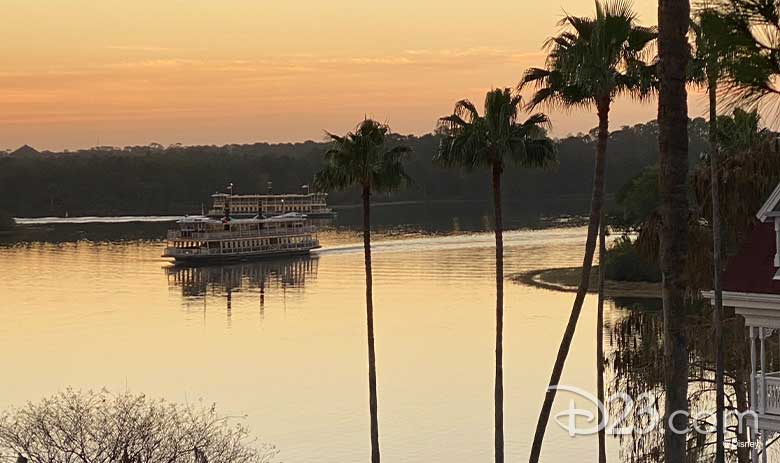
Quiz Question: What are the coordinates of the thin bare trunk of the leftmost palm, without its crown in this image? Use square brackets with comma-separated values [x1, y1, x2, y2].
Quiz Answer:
[363, 187, 380, 463]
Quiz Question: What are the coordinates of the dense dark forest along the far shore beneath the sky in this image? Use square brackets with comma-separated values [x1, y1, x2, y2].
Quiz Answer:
[0, 119, 706, 217]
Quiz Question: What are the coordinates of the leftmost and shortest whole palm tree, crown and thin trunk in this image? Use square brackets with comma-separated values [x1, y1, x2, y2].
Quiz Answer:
[314, 119, 411, 463]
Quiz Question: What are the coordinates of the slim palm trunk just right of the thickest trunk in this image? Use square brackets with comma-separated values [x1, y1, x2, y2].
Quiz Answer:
[708, 77, 726, 463]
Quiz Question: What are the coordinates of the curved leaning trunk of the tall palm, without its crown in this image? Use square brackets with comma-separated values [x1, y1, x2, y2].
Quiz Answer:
[528, 97, 610, 463]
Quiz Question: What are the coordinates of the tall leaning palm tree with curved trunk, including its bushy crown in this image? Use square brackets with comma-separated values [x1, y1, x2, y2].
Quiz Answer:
[520, 0, 657, 463]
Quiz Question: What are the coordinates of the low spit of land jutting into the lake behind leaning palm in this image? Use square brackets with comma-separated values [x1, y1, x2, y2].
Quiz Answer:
[509, 265, 661, 298]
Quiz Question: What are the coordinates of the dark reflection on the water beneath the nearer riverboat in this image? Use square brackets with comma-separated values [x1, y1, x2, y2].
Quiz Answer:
[166, 256, 318, 297]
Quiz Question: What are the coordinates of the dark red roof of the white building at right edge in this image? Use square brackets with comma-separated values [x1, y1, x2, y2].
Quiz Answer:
[723, 220, 780, 294]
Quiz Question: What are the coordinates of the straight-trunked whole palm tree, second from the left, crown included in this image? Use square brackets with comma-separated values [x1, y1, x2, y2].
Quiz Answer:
[434, 88, 555, 463]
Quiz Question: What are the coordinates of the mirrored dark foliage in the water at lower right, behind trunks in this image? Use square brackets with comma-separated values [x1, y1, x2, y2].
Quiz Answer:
[604, 299, 760, 463]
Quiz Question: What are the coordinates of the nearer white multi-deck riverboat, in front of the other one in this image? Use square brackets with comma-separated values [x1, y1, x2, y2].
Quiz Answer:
[163, 210, 320, 263]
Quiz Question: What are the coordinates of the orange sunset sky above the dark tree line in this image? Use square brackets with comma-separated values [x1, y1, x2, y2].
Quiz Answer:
[0, 0, 705, 150]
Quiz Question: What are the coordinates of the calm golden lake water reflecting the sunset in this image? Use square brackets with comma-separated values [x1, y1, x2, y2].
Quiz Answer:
[0, 205, 656, 463]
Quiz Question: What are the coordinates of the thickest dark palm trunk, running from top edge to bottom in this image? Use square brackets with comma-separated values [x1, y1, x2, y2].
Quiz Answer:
[658, 0, 690, 463]
